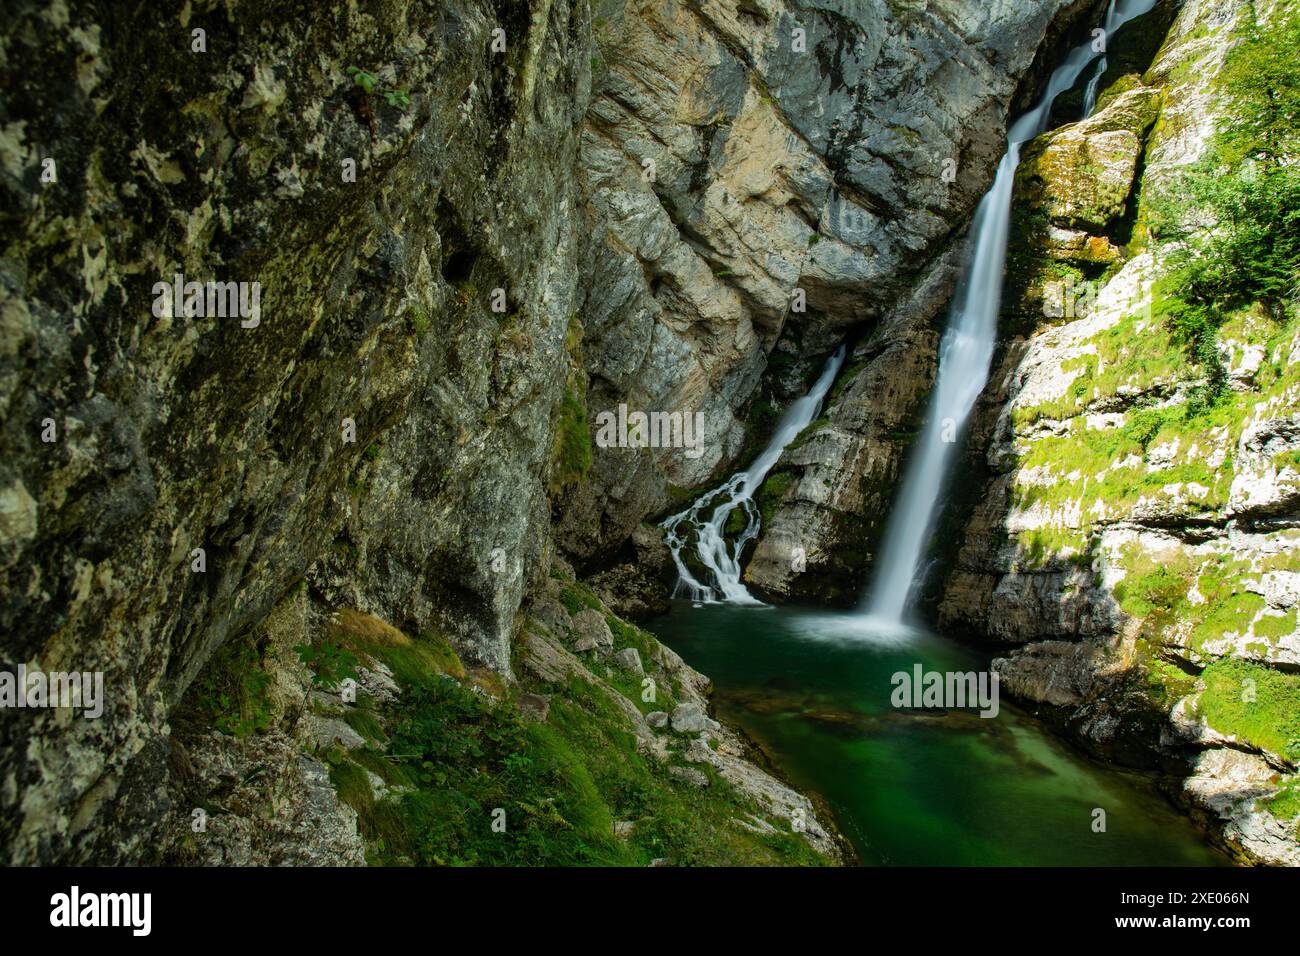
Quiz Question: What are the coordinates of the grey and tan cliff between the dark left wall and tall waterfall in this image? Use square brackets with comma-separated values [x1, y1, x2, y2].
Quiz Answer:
[558, 0, 1088, 567]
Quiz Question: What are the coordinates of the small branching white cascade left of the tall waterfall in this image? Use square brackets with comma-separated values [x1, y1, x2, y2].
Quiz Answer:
[660, 346, 844, 605]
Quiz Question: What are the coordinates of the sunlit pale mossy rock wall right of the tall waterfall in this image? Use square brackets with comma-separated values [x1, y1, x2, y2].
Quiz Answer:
[939, 0, 1300, 865]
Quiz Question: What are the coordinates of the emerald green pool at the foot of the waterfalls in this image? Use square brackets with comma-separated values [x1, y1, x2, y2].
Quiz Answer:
[650, 602, 1229, 866]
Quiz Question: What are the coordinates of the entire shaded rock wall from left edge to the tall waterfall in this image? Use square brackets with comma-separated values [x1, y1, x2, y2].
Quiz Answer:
[0, 0, 1080, 862]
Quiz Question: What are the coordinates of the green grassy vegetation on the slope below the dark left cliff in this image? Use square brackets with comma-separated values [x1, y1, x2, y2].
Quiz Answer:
[314, 590, 826, 866]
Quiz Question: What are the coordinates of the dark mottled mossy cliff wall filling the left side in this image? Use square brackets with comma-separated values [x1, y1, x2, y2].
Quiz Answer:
[0, 0, 590, 862]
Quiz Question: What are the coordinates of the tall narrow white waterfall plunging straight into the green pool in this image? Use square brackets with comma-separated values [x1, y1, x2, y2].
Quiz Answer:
[862, 0, 1156, 626]
